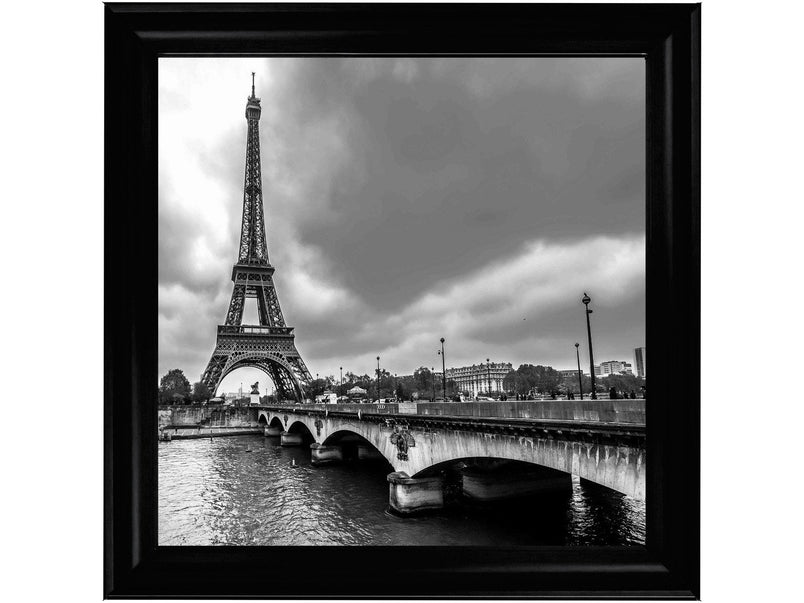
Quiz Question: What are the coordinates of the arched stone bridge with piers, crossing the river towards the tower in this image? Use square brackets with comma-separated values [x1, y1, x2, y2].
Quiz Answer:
[252, 400, 645, 514]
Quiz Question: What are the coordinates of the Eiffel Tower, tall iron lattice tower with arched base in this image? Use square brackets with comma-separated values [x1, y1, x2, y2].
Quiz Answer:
[201, 73, 312, 402]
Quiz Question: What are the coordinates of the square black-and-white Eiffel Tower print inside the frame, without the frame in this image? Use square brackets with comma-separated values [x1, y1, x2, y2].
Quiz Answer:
[158, 57, 647, 546]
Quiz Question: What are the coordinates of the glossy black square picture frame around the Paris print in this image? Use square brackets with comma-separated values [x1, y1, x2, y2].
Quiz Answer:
[103, 4, 701, 599]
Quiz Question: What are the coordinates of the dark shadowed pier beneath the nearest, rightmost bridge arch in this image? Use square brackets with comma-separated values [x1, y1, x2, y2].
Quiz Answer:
[461, 467, 572, 503]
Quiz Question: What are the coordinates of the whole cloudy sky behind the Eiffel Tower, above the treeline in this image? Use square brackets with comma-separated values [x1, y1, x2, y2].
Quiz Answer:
[159, 58, 645, 391]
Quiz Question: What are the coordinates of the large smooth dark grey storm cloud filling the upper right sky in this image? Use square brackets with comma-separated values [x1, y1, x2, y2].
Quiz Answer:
[266, 60, 644, 308]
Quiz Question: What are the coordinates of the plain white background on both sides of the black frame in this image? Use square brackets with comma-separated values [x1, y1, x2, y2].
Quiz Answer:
[0, 0, 804, 603]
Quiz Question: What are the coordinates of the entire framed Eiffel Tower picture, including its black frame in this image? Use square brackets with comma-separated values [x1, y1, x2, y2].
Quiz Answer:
[105, 4, 700, 599]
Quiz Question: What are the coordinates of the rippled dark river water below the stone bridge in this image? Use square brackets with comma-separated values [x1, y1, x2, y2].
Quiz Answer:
[159, 435, 645, 546]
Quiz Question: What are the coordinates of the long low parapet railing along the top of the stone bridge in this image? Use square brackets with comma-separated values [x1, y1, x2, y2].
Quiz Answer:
[260, 399, 645, 425]
